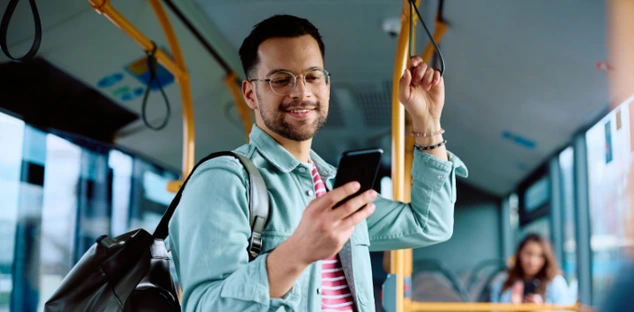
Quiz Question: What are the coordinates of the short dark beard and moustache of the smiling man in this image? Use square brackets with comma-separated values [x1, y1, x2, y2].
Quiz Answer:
[256, 91, 328, 141]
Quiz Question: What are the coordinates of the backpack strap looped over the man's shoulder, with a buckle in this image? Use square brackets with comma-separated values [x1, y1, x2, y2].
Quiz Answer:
[153, 152, 269, 261]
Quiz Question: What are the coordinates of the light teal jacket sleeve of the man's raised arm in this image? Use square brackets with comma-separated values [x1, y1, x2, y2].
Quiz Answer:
[367, 150, 468, 251]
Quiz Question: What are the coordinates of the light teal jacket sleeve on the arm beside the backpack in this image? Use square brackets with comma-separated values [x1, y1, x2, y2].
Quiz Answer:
[168, 157, 300, 311]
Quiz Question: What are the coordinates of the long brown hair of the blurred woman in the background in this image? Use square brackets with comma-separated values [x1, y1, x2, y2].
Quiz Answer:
[502, 234, 560, 296]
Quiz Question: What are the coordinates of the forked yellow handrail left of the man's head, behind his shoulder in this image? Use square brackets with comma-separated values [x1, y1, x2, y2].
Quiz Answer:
[88, 0, 195, 192]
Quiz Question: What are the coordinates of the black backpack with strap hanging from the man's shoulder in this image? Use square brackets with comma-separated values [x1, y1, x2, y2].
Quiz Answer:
[44, 152, 269, 312]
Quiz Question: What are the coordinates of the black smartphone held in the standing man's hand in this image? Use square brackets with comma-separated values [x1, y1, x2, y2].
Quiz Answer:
[333, 148, 383, 208]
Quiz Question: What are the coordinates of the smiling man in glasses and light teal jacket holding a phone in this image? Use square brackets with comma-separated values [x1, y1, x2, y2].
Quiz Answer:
[170, 15, 467, 311]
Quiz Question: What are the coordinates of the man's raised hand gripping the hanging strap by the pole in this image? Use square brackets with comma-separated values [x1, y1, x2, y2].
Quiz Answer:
[398, 56, 445, 131]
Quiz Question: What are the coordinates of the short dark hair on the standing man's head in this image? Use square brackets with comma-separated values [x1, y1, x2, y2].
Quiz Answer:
[239, 15, 326, 79]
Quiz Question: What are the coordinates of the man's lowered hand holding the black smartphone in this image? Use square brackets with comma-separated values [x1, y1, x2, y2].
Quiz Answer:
[288, 182, 377, 265]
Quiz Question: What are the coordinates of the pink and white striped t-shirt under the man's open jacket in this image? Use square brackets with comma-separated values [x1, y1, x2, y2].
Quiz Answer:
[311, 163, 354, 311]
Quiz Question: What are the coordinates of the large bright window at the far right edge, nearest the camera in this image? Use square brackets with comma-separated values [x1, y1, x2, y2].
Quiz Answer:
[586, 103, 632, 304]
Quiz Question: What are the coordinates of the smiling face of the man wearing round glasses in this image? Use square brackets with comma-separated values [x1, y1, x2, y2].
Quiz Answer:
[246, 35, 330, 141]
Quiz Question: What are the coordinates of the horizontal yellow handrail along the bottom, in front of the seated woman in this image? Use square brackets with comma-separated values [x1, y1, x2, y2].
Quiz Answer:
[410, 302, 592, 312]
